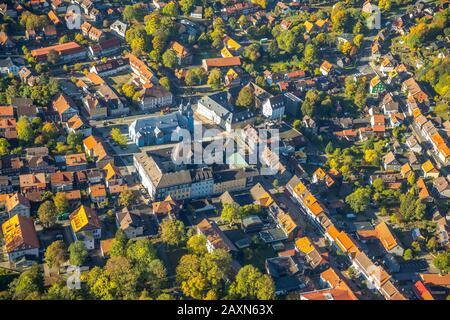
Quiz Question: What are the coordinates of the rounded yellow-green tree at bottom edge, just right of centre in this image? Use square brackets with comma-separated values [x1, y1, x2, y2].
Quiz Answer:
[229, 265, 275, 300]
